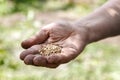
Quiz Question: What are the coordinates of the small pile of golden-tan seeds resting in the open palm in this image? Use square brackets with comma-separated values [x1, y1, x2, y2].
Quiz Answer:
[39, 44, 62, 56]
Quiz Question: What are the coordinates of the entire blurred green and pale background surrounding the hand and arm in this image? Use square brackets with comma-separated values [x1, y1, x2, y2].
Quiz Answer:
[0, 0, 120, 80]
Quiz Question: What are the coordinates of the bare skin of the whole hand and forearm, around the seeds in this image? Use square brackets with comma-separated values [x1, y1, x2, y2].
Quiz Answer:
[20, 0, 120, 68]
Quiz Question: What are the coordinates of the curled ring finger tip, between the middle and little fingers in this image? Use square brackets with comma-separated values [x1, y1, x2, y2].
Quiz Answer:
[33, 55, 47, 67]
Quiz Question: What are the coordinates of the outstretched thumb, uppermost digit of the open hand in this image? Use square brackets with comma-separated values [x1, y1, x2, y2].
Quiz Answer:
[21, 29, 48, 49]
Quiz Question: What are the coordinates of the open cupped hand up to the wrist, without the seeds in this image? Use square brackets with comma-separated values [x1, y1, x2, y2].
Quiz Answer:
[20, 22, 88, 68]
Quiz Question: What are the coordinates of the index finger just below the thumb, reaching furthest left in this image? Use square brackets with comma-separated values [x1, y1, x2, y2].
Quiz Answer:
[20, 45, 42, 60]
